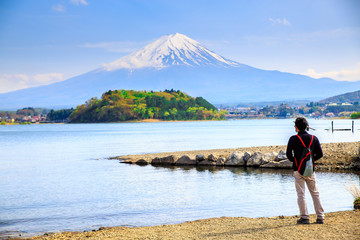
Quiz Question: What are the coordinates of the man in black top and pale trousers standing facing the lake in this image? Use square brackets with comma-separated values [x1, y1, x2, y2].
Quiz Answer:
[286, 117, 324, 224]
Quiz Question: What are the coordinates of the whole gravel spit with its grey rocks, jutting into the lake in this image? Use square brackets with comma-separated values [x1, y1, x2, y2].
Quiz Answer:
[113, 142, 360, 171]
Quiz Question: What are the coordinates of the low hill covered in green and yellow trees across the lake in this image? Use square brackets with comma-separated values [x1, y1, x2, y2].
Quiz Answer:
[69, 89, 227, 123]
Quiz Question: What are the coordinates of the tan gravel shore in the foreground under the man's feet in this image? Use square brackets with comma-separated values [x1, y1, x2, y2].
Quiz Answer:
[23, 210, 360, 240]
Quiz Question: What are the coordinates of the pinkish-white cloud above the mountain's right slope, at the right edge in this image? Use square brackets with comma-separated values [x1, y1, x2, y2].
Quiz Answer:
[303, 62, 360, 81]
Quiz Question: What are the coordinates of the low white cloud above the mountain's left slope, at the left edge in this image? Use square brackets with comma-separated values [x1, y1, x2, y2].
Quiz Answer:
[0, 73, 64, 93]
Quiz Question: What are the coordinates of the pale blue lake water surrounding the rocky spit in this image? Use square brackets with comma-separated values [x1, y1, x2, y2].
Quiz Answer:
[0, 120, 360, 236]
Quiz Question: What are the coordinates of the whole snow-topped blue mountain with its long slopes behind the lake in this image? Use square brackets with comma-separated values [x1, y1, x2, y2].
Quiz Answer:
[0, 33, 360, 109]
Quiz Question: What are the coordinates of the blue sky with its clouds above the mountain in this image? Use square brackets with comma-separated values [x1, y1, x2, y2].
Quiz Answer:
[0, 0, 360, 93]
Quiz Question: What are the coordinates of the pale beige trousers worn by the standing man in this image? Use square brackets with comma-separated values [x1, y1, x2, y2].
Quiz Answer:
[294, 171, 325, 219]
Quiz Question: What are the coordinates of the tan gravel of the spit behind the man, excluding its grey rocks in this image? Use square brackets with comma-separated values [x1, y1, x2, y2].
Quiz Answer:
[116, 142, 360, 171]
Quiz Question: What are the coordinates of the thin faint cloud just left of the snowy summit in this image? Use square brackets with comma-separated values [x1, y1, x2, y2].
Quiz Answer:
[81, 41, 149, 53]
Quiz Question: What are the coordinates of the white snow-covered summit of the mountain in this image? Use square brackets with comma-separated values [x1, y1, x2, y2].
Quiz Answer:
[103, 33, 240, 71]
